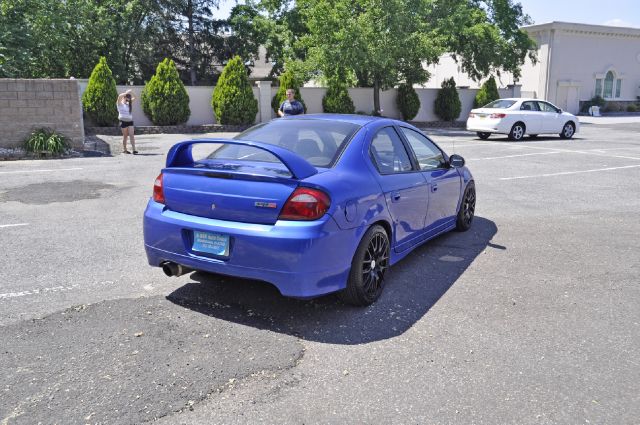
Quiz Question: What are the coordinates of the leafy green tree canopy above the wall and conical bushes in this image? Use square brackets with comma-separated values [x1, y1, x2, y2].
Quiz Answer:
[0, 0, 534, 100]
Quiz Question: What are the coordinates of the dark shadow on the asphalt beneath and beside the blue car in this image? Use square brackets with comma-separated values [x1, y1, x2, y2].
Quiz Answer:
[167, 217, 498, 345]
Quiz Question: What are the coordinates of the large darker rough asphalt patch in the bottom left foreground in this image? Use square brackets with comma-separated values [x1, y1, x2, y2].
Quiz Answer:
[0, 297, 303, 424]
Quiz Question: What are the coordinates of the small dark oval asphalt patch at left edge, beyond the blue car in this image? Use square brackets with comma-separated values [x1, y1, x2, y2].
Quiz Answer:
[0, 180, 117, 205]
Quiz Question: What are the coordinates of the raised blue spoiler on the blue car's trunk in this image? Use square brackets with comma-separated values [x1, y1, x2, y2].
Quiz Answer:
[167, 139, 318, 180]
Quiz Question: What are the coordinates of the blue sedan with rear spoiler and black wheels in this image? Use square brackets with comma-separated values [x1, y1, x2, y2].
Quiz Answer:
[144, 114, 476, 305]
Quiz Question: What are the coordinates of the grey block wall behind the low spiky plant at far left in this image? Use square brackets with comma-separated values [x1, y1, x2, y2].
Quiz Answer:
[0, 78, 84, 150]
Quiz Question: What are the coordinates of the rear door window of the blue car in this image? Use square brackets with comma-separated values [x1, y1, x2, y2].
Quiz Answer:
[369, 127, 413, 174]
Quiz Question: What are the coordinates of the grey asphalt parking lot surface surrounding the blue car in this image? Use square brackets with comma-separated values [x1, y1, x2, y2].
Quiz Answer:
[0, 118, 640, 425]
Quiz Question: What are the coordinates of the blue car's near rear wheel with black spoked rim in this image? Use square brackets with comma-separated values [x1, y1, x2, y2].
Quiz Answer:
[338, 224, 390, 306]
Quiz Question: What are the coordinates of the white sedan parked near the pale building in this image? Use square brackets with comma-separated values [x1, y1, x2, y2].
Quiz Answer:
[467, 98, 580, 140]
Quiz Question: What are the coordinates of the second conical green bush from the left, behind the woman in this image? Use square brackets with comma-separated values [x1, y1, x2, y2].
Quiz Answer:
[141, 58, 191, 125]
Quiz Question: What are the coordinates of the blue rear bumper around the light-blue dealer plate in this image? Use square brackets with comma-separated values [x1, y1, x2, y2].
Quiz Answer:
[144, 200, 360, 298]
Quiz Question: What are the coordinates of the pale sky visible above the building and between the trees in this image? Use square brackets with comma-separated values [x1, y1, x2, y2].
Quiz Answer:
[215, 0, 640, 28]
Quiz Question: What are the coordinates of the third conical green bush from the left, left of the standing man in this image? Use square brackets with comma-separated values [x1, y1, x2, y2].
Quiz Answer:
[211, 56, 258, 125]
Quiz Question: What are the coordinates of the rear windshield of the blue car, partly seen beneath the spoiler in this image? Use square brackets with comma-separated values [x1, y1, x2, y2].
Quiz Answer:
[209, 118, 360, 167]
